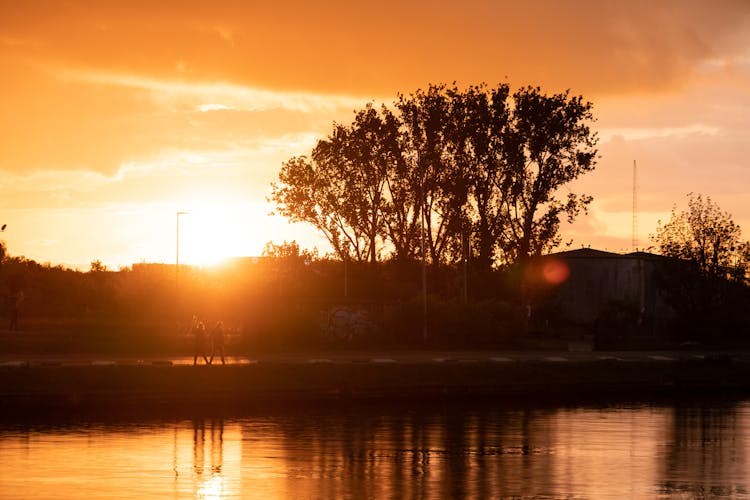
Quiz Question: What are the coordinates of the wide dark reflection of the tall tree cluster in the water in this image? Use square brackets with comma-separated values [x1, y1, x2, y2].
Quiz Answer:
[242, 404, 556, 498]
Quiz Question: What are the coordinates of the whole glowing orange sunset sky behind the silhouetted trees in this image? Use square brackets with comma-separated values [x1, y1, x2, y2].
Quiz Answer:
[0, 0, 750, 270]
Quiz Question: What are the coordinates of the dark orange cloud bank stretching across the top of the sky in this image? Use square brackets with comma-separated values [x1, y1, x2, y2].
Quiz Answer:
[0, 0, 750, 96]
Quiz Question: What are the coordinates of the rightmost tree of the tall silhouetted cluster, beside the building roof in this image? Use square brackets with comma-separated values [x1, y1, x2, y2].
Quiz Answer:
[498, 87, 597, 263]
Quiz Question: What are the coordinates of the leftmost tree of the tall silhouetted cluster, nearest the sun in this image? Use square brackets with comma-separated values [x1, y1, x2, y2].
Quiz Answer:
[271, 105, 398, 262]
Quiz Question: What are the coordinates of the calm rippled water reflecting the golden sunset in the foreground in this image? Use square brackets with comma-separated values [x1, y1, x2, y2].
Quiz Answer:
[0, 401, 750, 499]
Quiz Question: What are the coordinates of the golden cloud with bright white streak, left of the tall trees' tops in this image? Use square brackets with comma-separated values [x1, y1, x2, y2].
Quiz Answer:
[0, 57, 361, 175]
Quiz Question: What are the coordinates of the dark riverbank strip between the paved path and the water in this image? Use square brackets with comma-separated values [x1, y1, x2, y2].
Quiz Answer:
[0, 352, 750, 413]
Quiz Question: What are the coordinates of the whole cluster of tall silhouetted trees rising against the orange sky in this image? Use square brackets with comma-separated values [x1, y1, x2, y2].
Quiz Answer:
[270, 84, 597, 269]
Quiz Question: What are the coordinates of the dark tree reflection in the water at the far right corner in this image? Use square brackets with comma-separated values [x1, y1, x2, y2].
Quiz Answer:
[659, 405, 748, 498]
